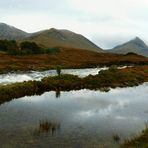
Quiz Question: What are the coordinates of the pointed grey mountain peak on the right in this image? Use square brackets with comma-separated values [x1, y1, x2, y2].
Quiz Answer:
[109, 37, 148, 56]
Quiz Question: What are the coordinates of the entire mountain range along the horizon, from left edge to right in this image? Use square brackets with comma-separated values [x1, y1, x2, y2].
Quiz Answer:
[0, 23, 148, 56]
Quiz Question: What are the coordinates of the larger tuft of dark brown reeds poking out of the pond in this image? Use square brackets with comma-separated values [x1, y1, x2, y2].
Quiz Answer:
[38, 120, 61, 136]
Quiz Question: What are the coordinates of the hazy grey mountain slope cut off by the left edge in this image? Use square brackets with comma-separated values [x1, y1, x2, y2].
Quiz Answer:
[0, 23, 30, 40]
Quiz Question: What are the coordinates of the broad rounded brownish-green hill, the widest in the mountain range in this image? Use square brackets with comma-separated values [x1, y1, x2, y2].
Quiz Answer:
[24, 28, 103, 52]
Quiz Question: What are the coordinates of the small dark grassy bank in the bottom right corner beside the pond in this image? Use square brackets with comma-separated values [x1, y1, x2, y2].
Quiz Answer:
[121, 127, 148, 148]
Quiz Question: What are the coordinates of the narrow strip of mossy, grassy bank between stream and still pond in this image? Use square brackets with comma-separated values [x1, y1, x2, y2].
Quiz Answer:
[0, 66, 148, 103]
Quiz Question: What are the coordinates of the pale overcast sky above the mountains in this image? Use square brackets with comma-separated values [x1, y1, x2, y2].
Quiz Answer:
[0, 0, 148, 48]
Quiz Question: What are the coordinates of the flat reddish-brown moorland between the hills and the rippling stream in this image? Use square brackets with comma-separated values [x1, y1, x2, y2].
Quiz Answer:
[0, 48, 148, 73]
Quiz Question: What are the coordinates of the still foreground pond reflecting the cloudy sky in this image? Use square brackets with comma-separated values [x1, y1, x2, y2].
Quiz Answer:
[0, 83, 148, 148]
